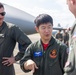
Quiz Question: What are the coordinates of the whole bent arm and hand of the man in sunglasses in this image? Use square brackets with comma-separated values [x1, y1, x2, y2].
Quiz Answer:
[2, 25, 31, 66]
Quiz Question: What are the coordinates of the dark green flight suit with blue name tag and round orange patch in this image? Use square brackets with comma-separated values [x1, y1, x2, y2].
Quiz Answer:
[20, 37, 68, 75]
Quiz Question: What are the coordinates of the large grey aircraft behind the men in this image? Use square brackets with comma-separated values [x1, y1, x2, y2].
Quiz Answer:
[4, 4, 66, 34]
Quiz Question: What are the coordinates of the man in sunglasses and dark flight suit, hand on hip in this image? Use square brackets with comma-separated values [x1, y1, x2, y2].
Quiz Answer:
[0, 3, 31, 75]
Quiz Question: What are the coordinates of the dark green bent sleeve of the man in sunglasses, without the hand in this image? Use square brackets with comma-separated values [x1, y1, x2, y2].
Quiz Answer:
[11, 26, 31, 61]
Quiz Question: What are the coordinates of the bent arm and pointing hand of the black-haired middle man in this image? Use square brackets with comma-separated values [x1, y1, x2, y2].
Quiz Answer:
[20, 44, 38, 72]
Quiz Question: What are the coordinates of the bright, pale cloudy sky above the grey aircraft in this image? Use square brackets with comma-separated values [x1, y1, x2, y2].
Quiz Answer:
[0, 0, 75, 27]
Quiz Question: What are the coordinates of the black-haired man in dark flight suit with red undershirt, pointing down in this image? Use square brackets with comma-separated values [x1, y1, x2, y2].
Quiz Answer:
[20, 14, 67, 75]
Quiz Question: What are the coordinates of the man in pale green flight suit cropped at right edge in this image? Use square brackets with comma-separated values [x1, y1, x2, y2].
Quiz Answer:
[64, 0, 76, 75]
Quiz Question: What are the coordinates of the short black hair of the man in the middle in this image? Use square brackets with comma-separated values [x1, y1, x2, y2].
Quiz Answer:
[34, 14, 53, 27]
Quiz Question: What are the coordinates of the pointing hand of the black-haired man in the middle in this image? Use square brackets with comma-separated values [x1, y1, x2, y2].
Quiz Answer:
[24, 60, 38, 73]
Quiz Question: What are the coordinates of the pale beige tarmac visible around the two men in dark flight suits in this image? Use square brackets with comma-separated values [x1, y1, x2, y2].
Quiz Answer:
[14, 33, 40, 75]
